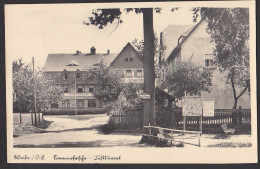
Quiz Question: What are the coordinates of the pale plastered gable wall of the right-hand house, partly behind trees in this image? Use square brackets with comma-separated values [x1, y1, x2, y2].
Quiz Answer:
[167, 21, 251, 109]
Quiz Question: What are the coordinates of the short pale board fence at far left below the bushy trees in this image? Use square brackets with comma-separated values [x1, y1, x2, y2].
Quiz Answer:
[13, 113, 43, 125]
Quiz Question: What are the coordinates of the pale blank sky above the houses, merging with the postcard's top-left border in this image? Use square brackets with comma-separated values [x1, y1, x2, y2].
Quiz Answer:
[5, 4, 199, 67]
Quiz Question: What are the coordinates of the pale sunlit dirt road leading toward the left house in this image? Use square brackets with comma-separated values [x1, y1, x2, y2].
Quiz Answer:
[14, 114, 141, 148]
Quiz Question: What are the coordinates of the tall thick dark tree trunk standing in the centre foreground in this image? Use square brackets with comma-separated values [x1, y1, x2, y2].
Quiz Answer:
[139, 8, 156, 144]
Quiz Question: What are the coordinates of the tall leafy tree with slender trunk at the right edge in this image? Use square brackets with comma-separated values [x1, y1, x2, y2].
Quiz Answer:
[193, 8, 250, 109]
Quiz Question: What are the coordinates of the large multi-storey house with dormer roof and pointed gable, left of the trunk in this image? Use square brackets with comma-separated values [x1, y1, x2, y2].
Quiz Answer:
[44, 43, 144, 113]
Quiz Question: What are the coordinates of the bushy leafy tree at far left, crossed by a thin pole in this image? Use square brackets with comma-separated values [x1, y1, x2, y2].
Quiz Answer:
[13, 60, 62, 112]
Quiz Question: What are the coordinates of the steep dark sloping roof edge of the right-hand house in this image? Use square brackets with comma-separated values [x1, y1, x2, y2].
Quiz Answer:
[166, 18, 205, 62]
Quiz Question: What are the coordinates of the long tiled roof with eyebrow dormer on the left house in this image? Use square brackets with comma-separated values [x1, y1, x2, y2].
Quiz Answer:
[44, 53, 118, 72]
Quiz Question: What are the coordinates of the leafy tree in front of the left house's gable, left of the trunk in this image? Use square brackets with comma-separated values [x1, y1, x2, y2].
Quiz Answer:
[87, 61, 141, 113]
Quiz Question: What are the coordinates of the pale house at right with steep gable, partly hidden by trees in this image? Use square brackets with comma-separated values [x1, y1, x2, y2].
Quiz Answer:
[161, 19, 250, 109]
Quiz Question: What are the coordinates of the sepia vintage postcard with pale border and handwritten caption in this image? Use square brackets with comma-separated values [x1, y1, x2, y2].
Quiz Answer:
[5, 1, 257, 163]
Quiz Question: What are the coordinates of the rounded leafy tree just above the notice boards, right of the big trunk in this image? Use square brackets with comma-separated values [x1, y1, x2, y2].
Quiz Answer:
[166, 61, 212, 99]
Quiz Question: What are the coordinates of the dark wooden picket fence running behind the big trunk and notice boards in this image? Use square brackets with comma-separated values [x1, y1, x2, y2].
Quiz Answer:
[110, 109, 251, 131]
